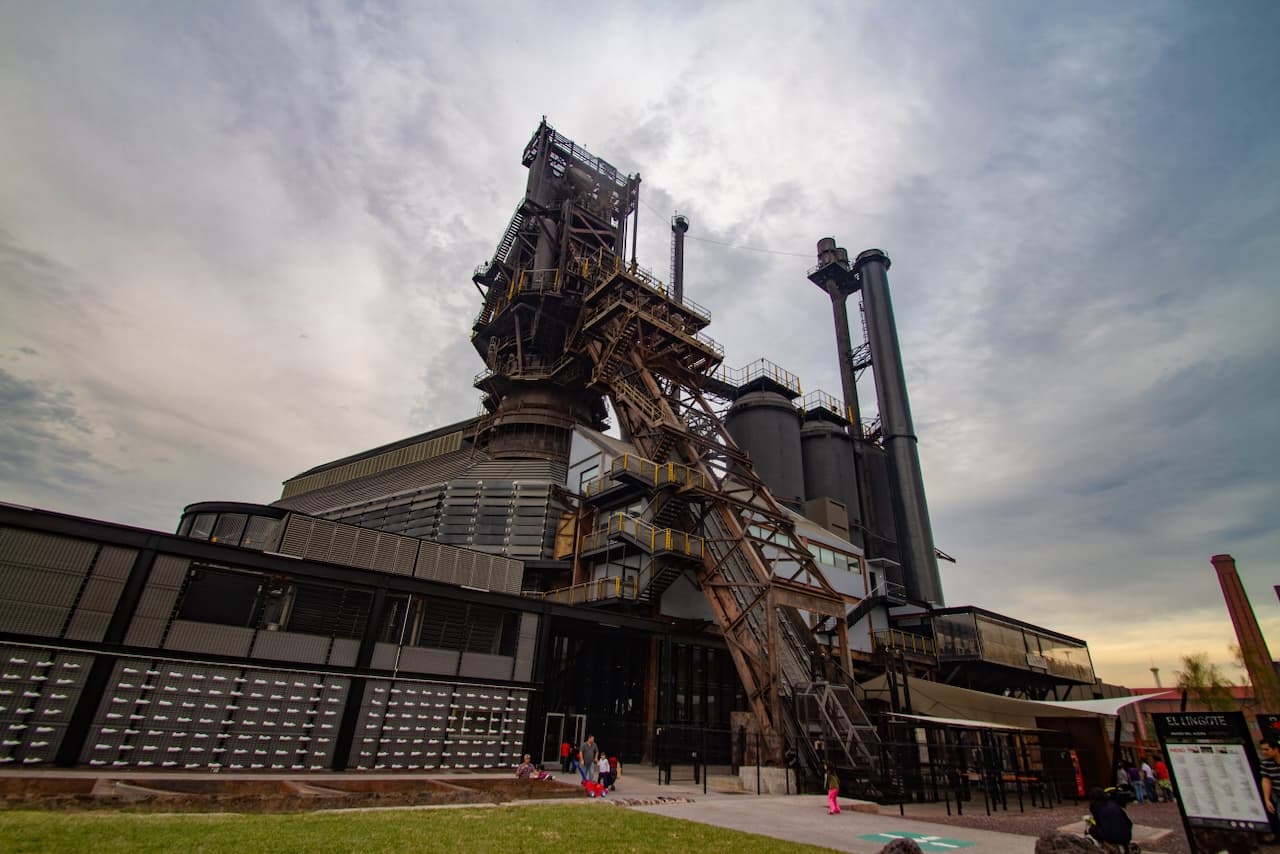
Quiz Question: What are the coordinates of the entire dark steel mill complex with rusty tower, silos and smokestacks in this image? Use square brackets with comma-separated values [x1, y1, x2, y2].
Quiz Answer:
[0, 120, 1092, 785]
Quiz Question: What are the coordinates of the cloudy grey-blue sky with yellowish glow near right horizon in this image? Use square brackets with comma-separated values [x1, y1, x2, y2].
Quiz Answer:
[0, 0, 1280, 686]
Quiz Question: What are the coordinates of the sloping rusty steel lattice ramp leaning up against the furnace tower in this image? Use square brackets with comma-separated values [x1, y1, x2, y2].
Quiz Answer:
[580, 265, 879, 777]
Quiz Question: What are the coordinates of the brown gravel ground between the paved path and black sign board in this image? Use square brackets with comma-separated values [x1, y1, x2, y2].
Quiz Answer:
[881, 802, 1187, 854]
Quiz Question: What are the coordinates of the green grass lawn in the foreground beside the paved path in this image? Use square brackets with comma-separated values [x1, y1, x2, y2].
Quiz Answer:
[0, 804, 828, 854]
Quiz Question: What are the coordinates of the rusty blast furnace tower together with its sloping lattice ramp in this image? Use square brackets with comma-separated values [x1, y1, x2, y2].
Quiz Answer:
[472, 119, 877, 771]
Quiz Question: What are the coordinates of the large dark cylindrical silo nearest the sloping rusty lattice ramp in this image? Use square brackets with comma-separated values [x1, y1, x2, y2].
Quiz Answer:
[724, 382, 804, 511]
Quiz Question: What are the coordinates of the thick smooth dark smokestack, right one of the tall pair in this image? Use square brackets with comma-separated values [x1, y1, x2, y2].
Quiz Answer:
[854, 250, 943, 604]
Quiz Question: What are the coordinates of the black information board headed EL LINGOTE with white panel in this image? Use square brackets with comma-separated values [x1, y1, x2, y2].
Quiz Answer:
[1152, 712, 1268, 832]
